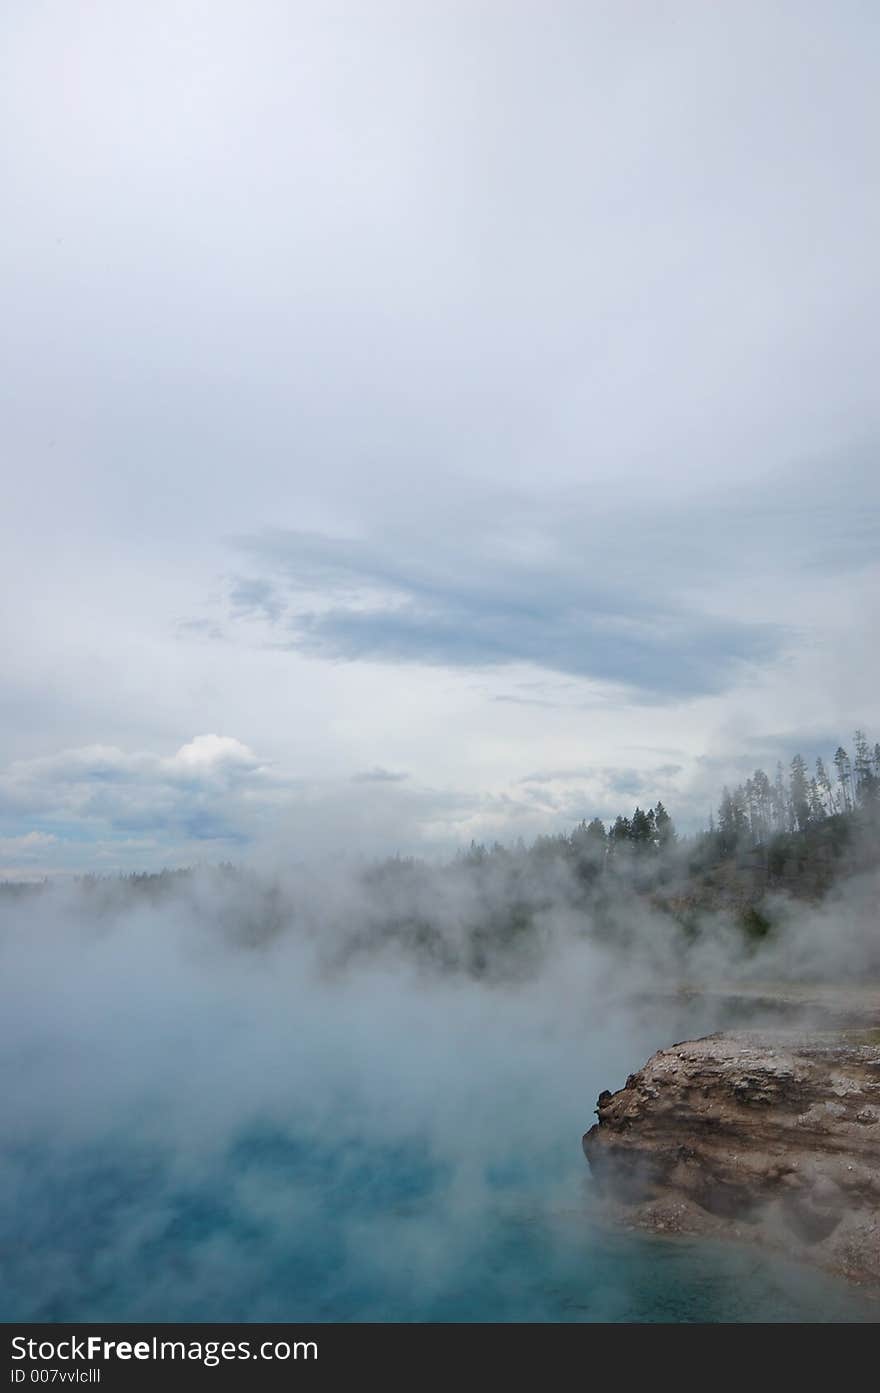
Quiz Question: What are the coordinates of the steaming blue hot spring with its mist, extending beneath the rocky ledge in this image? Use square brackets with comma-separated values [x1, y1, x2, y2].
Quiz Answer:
[0, 876, 870, 1321]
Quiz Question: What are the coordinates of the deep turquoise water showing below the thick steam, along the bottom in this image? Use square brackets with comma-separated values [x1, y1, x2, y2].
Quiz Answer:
[0, 1128, 877, 1322]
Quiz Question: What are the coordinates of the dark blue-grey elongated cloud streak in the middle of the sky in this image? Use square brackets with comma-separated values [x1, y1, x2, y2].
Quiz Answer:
[225, 529, 780, 699]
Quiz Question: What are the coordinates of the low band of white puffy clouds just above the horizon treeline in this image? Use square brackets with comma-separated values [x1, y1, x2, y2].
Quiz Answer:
[0, 734, 690, 879]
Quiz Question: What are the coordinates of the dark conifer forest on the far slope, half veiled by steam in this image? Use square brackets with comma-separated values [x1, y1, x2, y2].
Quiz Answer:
[0, 731, 880, 978]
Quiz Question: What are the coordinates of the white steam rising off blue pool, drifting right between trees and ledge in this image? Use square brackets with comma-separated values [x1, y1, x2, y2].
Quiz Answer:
[0, 862, 877, 1319]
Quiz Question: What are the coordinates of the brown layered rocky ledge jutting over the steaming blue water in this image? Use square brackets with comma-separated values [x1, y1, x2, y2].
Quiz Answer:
[583, 1031, 880, 1286]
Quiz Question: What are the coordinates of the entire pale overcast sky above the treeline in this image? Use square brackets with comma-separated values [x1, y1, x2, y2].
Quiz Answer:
[0, 0, 880, 875]
